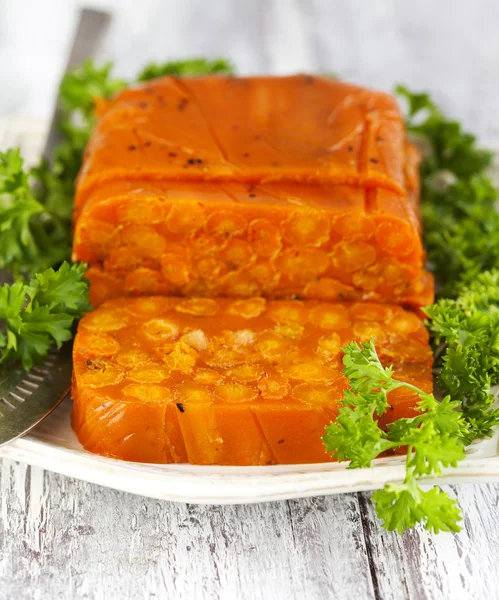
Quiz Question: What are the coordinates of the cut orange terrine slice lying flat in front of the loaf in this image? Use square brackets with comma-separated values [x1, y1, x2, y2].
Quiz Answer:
[73, 297, 432, 465]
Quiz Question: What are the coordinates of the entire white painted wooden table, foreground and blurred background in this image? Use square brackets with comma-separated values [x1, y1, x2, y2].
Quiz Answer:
[0, 0, 499, 600]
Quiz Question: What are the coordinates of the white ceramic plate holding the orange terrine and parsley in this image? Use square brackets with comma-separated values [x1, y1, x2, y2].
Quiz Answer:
[0, 118, 499, 504]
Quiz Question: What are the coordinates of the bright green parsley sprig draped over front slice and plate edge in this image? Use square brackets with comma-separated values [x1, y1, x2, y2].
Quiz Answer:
[323, 341, 469, 533]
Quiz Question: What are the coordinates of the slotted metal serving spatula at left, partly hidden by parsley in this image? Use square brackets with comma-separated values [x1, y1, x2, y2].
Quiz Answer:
[0, 9, 111, 446]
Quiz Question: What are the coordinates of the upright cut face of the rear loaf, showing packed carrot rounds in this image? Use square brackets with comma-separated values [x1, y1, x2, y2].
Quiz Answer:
[73, 183, 433, 306]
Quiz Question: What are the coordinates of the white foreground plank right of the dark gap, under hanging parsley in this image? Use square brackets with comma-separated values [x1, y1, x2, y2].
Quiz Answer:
[359, 485, 499, 600]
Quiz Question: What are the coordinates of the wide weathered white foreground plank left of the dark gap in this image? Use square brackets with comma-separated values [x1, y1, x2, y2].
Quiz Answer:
[0, 460, 374, 600]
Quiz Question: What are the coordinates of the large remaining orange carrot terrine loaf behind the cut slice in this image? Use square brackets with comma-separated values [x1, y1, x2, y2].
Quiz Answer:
[73, 76, 433, 307]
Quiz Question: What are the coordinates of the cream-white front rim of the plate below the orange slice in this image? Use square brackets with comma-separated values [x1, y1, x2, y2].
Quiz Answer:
[0, 424, 499, 505]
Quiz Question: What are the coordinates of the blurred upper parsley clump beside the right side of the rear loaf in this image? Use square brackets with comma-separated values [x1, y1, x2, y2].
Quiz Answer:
[396, 86, 499, 297]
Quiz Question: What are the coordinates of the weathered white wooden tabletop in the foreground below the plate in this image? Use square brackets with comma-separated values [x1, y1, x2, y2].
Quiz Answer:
[0, 460, 499, 600]
